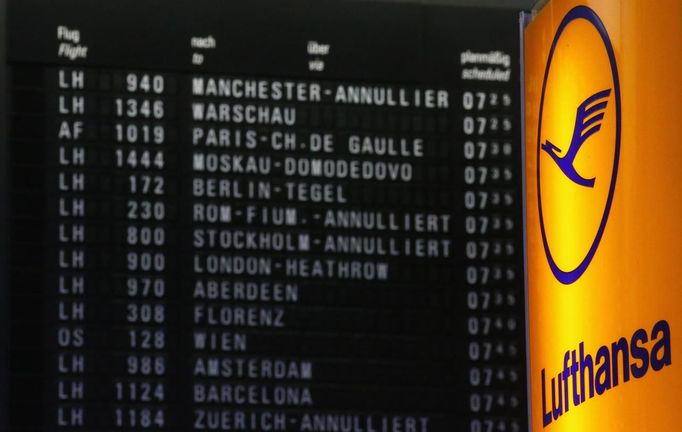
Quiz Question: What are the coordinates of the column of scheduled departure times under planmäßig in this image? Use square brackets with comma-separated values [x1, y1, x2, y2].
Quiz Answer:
[461, 87, 524, 432]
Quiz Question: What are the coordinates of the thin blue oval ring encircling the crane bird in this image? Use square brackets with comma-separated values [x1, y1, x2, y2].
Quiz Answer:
[537, 6, 621, 285]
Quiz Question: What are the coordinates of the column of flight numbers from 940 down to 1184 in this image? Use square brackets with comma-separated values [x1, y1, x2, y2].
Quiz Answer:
[108, 72, 174, 431]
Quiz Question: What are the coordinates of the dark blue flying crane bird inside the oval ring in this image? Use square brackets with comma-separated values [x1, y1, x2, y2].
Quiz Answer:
[541, 89, 611, 187]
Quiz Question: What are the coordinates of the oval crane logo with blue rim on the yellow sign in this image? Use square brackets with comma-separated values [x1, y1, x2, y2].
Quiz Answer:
[537, 6, 621, 284]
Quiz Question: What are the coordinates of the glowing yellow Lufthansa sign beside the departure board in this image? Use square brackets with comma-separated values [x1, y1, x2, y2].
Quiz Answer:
[524, 0, 682, 432]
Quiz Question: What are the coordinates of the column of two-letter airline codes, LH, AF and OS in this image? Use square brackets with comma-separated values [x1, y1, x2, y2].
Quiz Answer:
[45, 68, 91, 430]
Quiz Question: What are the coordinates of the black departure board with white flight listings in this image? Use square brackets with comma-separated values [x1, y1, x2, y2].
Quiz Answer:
[0, 0, 527, 432]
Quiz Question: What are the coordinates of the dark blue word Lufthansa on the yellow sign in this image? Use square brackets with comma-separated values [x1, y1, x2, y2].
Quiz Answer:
[540, 320, 672, 427]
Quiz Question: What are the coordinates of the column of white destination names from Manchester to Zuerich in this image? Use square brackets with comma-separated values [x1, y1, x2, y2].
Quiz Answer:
[183, 74, 454, 432]
